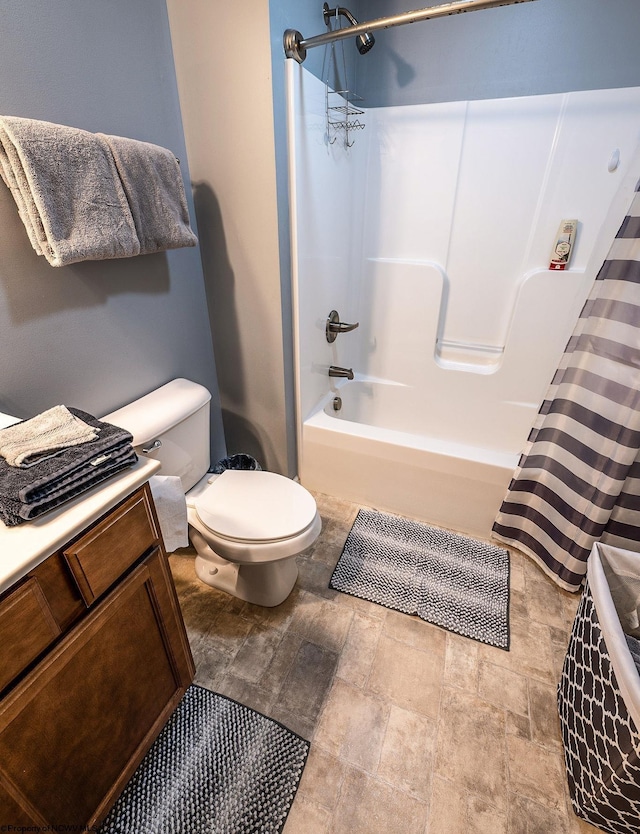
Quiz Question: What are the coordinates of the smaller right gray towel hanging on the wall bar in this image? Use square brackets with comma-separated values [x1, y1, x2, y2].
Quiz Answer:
[98, 133, 198, 255]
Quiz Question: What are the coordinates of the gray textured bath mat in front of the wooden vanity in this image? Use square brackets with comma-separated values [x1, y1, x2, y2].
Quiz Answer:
[100, 685, 309, 834]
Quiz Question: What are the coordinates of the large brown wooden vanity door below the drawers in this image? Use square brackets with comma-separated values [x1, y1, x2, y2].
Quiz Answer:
[0, 549, 194, 826]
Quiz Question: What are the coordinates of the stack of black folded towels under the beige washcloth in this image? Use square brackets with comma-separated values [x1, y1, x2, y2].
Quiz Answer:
[0, 408, 138, 527]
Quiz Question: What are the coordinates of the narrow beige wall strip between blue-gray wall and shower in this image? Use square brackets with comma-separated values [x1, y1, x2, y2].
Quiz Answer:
[167, 0, 295, 473]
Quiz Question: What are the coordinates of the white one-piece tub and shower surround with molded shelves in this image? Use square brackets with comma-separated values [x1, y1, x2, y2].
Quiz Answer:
[286, 59, 640, 538]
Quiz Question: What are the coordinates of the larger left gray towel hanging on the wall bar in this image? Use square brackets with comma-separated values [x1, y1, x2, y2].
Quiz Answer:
[0, 116, 140, 266]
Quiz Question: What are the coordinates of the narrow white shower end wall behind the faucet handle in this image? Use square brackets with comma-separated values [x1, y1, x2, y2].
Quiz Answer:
[286, 60, 368, 419]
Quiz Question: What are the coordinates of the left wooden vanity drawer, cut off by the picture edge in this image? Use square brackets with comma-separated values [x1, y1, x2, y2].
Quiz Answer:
[0, 578, 60, 690]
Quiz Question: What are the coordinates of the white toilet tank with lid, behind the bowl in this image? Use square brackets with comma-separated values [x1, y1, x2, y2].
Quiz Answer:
[102, 379, 211, 492]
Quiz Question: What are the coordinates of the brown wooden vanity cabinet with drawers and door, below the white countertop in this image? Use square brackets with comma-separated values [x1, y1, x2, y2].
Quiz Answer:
[0, 484, 194, 830]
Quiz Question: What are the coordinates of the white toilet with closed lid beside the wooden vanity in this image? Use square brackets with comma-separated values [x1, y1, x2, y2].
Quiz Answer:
[102, 379, 322, 607]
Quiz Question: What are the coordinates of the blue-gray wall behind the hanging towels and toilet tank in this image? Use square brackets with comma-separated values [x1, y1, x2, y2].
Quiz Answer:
[0, 0, 224, 459]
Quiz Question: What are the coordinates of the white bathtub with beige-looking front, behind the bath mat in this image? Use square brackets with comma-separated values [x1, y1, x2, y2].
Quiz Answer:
[300, 377, 524, 539]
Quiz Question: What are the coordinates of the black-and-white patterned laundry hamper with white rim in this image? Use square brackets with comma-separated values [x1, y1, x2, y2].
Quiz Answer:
[558, 543, 640, 834]
